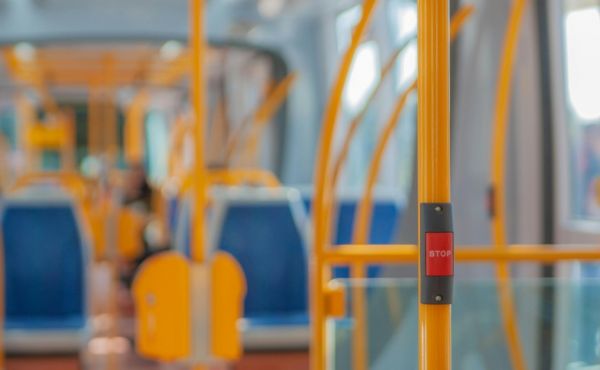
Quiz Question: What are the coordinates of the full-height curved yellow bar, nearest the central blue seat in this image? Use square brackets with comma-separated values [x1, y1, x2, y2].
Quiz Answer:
[311, 0, 377, 370]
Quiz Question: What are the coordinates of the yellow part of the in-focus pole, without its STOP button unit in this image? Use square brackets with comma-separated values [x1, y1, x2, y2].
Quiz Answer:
[417, 0, 452, 370]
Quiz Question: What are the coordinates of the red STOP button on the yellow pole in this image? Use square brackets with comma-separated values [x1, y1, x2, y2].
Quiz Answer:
[425, 233, 454, 276]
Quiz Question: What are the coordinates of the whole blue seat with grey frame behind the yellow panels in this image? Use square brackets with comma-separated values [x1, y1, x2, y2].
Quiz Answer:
[178, 189, 308, 348]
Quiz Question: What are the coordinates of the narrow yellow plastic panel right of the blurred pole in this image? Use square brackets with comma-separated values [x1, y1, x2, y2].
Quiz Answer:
[211, 252, 246, 360]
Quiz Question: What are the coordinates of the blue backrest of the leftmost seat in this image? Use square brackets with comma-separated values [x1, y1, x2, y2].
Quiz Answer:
[2, 202, 86, 330]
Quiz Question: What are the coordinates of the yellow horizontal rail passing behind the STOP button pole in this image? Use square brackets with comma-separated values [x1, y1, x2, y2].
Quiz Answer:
[323, 244, 600, 265]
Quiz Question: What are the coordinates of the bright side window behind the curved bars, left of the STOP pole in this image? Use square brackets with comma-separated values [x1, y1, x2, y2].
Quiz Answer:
[335, 0, 417, 196]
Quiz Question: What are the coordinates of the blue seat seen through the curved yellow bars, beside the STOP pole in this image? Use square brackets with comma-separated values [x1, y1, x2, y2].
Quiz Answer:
[302, 192, 403, 278]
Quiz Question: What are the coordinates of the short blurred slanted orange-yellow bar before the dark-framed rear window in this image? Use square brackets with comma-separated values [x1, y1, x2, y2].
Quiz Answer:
[225, 73, 298, 164]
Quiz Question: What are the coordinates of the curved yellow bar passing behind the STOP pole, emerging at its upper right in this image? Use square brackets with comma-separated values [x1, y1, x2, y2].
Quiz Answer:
[353, 5, 475, 244]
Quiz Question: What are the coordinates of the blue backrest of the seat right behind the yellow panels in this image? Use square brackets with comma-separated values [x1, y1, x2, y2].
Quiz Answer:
[217, 199, 307, 318]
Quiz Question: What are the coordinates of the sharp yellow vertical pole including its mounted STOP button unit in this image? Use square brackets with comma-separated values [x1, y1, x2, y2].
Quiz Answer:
[417, 0, 454, 370]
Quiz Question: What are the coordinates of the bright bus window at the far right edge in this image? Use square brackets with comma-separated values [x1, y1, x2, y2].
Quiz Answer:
[563, 0, 600, 221]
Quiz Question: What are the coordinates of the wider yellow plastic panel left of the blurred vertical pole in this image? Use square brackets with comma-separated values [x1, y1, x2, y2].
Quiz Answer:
[133, 252, 191, 361]
